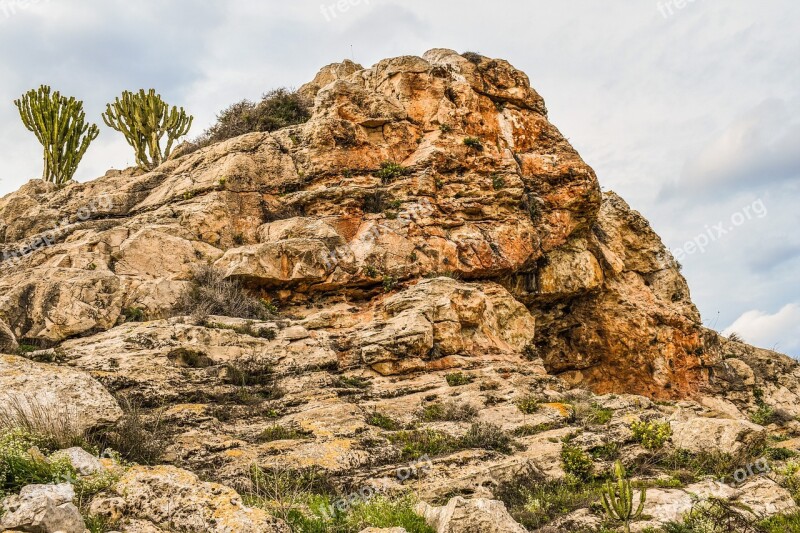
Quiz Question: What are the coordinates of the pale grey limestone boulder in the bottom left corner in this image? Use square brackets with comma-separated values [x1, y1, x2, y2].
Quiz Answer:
[0, 483, 85, 533]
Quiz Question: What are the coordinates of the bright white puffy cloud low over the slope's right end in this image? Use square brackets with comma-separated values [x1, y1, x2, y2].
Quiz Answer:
[723, 303, 800, 357]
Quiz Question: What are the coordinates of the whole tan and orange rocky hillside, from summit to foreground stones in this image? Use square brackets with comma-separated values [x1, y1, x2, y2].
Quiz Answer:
[0, 49, 800, 532]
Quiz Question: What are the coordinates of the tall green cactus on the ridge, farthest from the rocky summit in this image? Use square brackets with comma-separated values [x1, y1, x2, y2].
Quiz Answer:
[14, 85, 100, 185]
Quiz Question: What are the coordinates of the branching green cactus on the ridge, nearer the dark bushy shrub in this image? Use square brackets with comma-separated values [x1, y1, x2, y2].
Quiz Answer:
[103, 89, 194, 170]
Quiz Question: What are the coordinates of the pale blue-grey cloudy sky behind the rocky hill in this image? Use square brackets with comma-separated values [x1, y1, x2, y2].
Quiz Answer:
[0, 0, 800, 357]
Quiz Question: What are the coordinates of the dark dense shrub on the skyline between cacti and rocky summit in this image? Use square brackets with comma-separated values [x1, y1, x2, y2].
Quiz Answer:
[195, 88, 312, 147]
